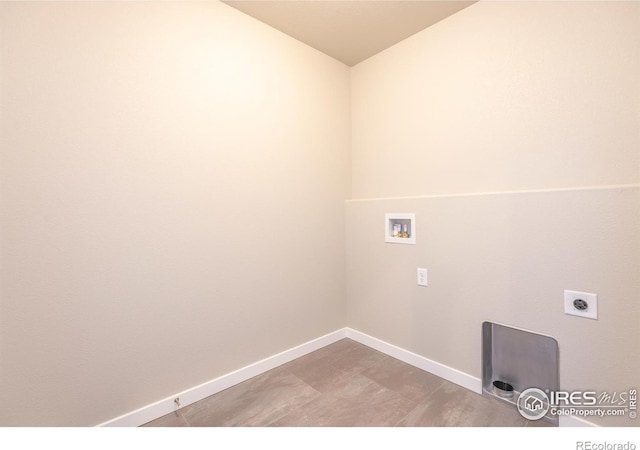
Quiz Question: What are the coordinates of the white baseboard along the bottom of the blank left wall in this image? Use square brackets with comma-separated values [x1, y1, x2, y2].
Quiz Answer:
[98, 328, 347, 427]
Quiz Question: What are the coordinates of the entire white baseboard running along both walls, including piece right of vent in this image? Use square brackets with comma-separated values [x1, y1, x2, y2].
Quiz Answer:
[98, 328, 597, 427]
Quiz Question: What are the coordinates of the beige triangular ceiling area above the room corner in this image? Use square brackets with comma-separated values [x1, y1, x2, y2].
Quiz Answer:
[223, 0, 475, 66]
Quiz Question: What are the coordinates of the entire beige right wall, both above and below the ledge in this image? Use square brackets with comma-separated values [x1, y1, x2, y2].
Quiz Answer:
[346, 2, 640, 426]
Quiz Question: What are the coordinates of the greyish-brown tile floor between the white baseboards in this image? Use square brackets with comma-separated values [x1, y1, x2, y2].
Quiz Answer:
[144, 339, 549, 427]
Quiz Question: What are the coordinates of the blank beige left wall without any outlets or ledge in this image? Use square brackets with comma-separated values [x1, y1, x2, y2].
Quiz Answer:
[0, 2, 350, 426]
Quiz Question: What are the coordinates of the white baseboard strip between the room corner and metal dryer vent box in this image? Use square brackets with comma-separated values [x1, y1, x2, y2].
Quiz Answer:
[347, 328, 482, 394]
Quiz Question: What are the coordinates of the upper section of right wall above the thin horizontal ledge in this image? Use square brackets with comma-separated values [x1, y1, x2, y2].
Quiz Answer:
[352, 2, 640, 199]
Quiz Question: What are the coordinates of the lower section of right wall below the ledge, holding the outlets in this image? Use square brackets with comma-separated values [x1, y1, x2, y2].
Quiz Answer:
[347, 188, 640, 425]
